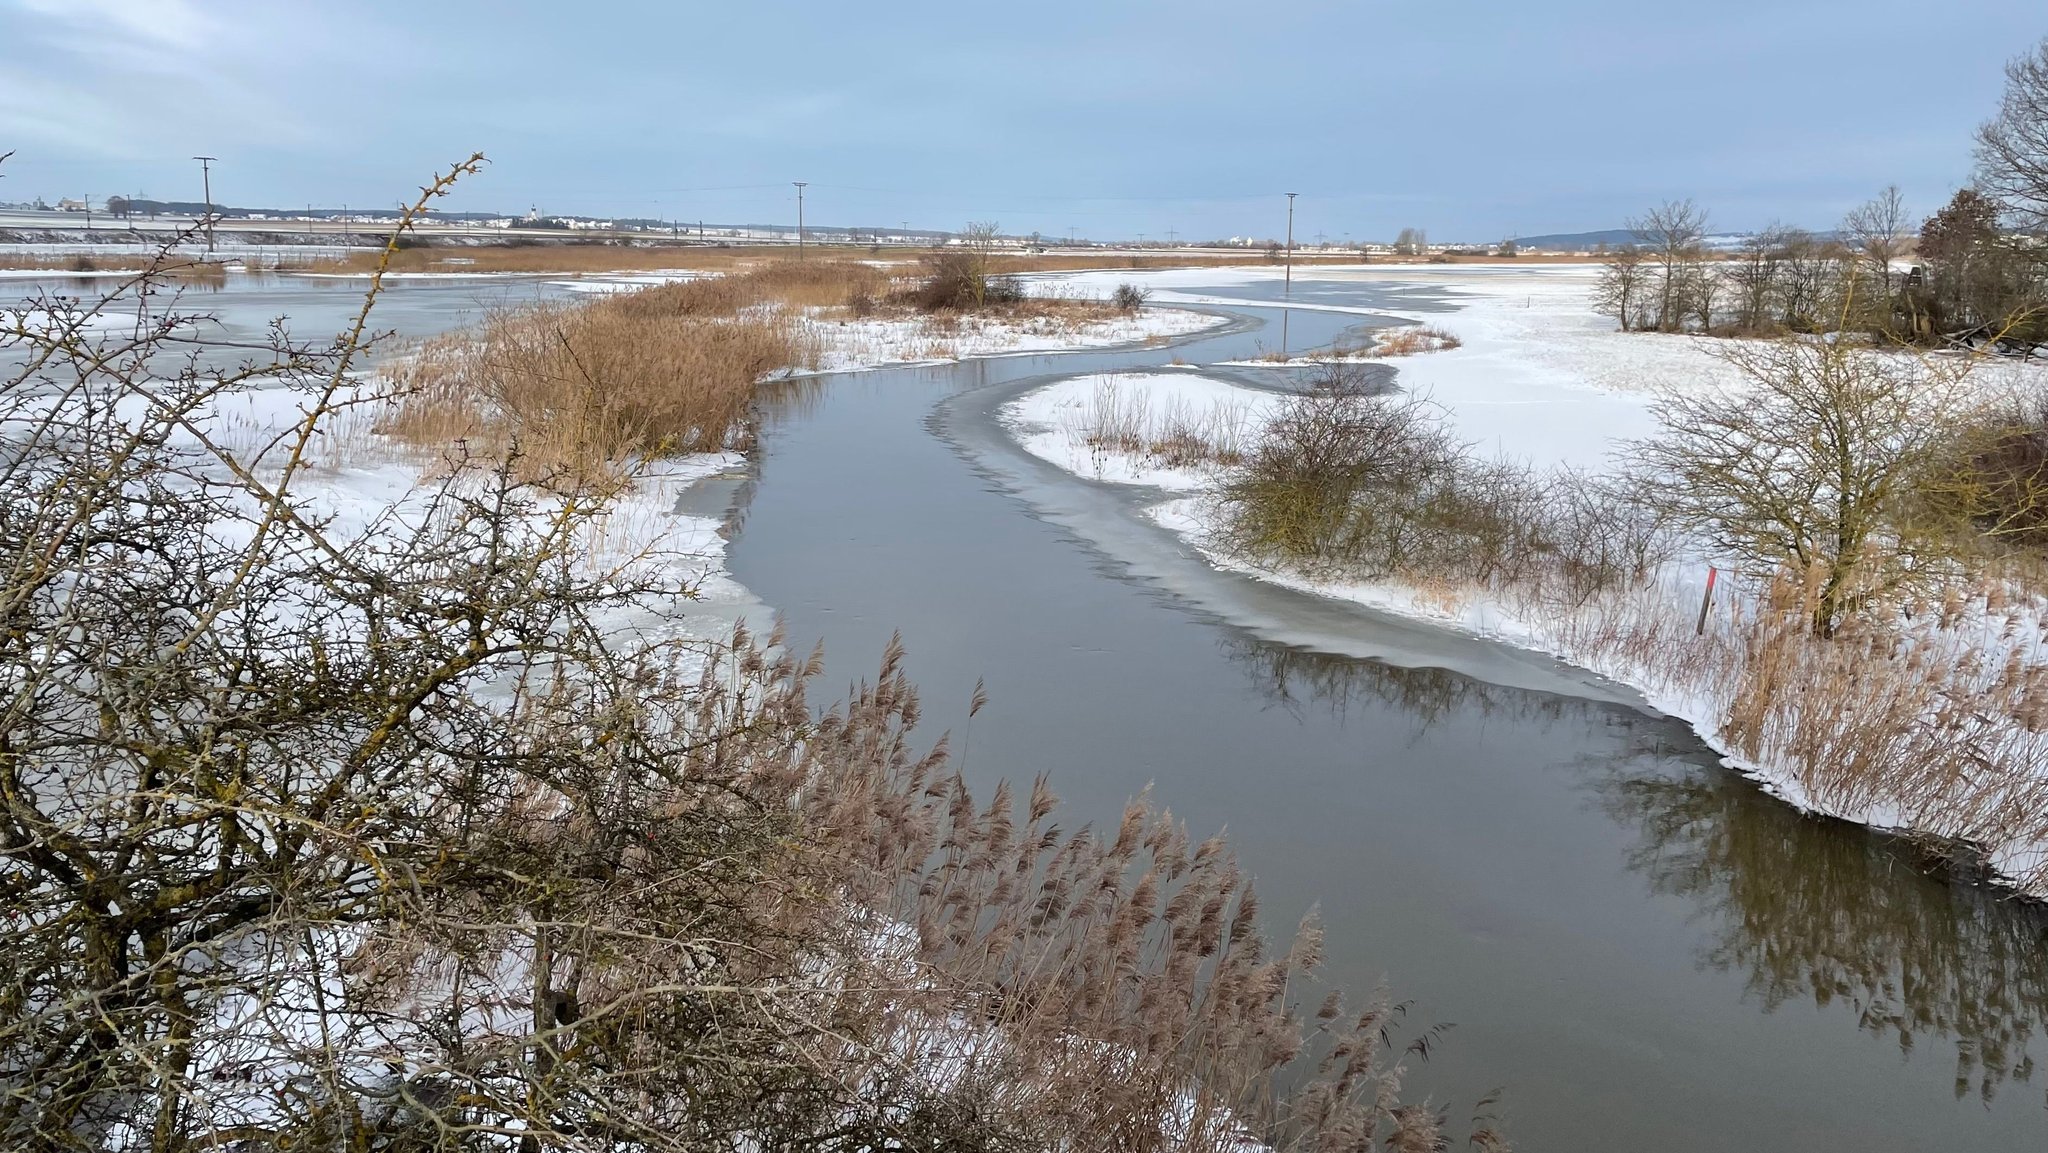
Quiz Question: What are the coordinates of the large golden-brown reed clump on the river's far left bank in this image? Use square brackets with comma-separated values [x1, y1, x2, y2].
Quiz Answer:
[383, 296, 801, 477]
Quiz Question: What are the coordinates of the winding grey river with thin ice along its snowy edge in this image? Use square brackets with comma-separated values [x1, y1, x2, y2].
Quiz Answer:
[729, 276, 2048, 1153]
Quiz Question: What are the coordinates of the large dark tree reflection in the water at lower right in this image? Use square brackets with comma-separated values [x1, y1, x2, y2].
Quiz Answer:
[1589, 766, 2048, 1104]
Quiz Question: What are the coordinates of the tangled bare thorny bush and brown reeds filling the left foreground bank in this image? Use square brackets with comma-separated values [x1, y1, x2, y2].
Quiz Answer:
[0, 158, 1503, 1153]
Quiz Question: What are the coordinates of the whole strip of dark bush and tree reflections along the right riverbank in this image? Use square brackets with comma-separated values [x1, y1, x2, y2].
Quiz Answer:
[1229, 639, 2048, 1104]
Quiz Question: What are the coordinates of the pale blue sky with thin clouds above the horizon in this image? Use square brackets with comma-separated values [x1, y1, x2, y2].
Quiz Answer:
[0, 0, 2048, 242]
